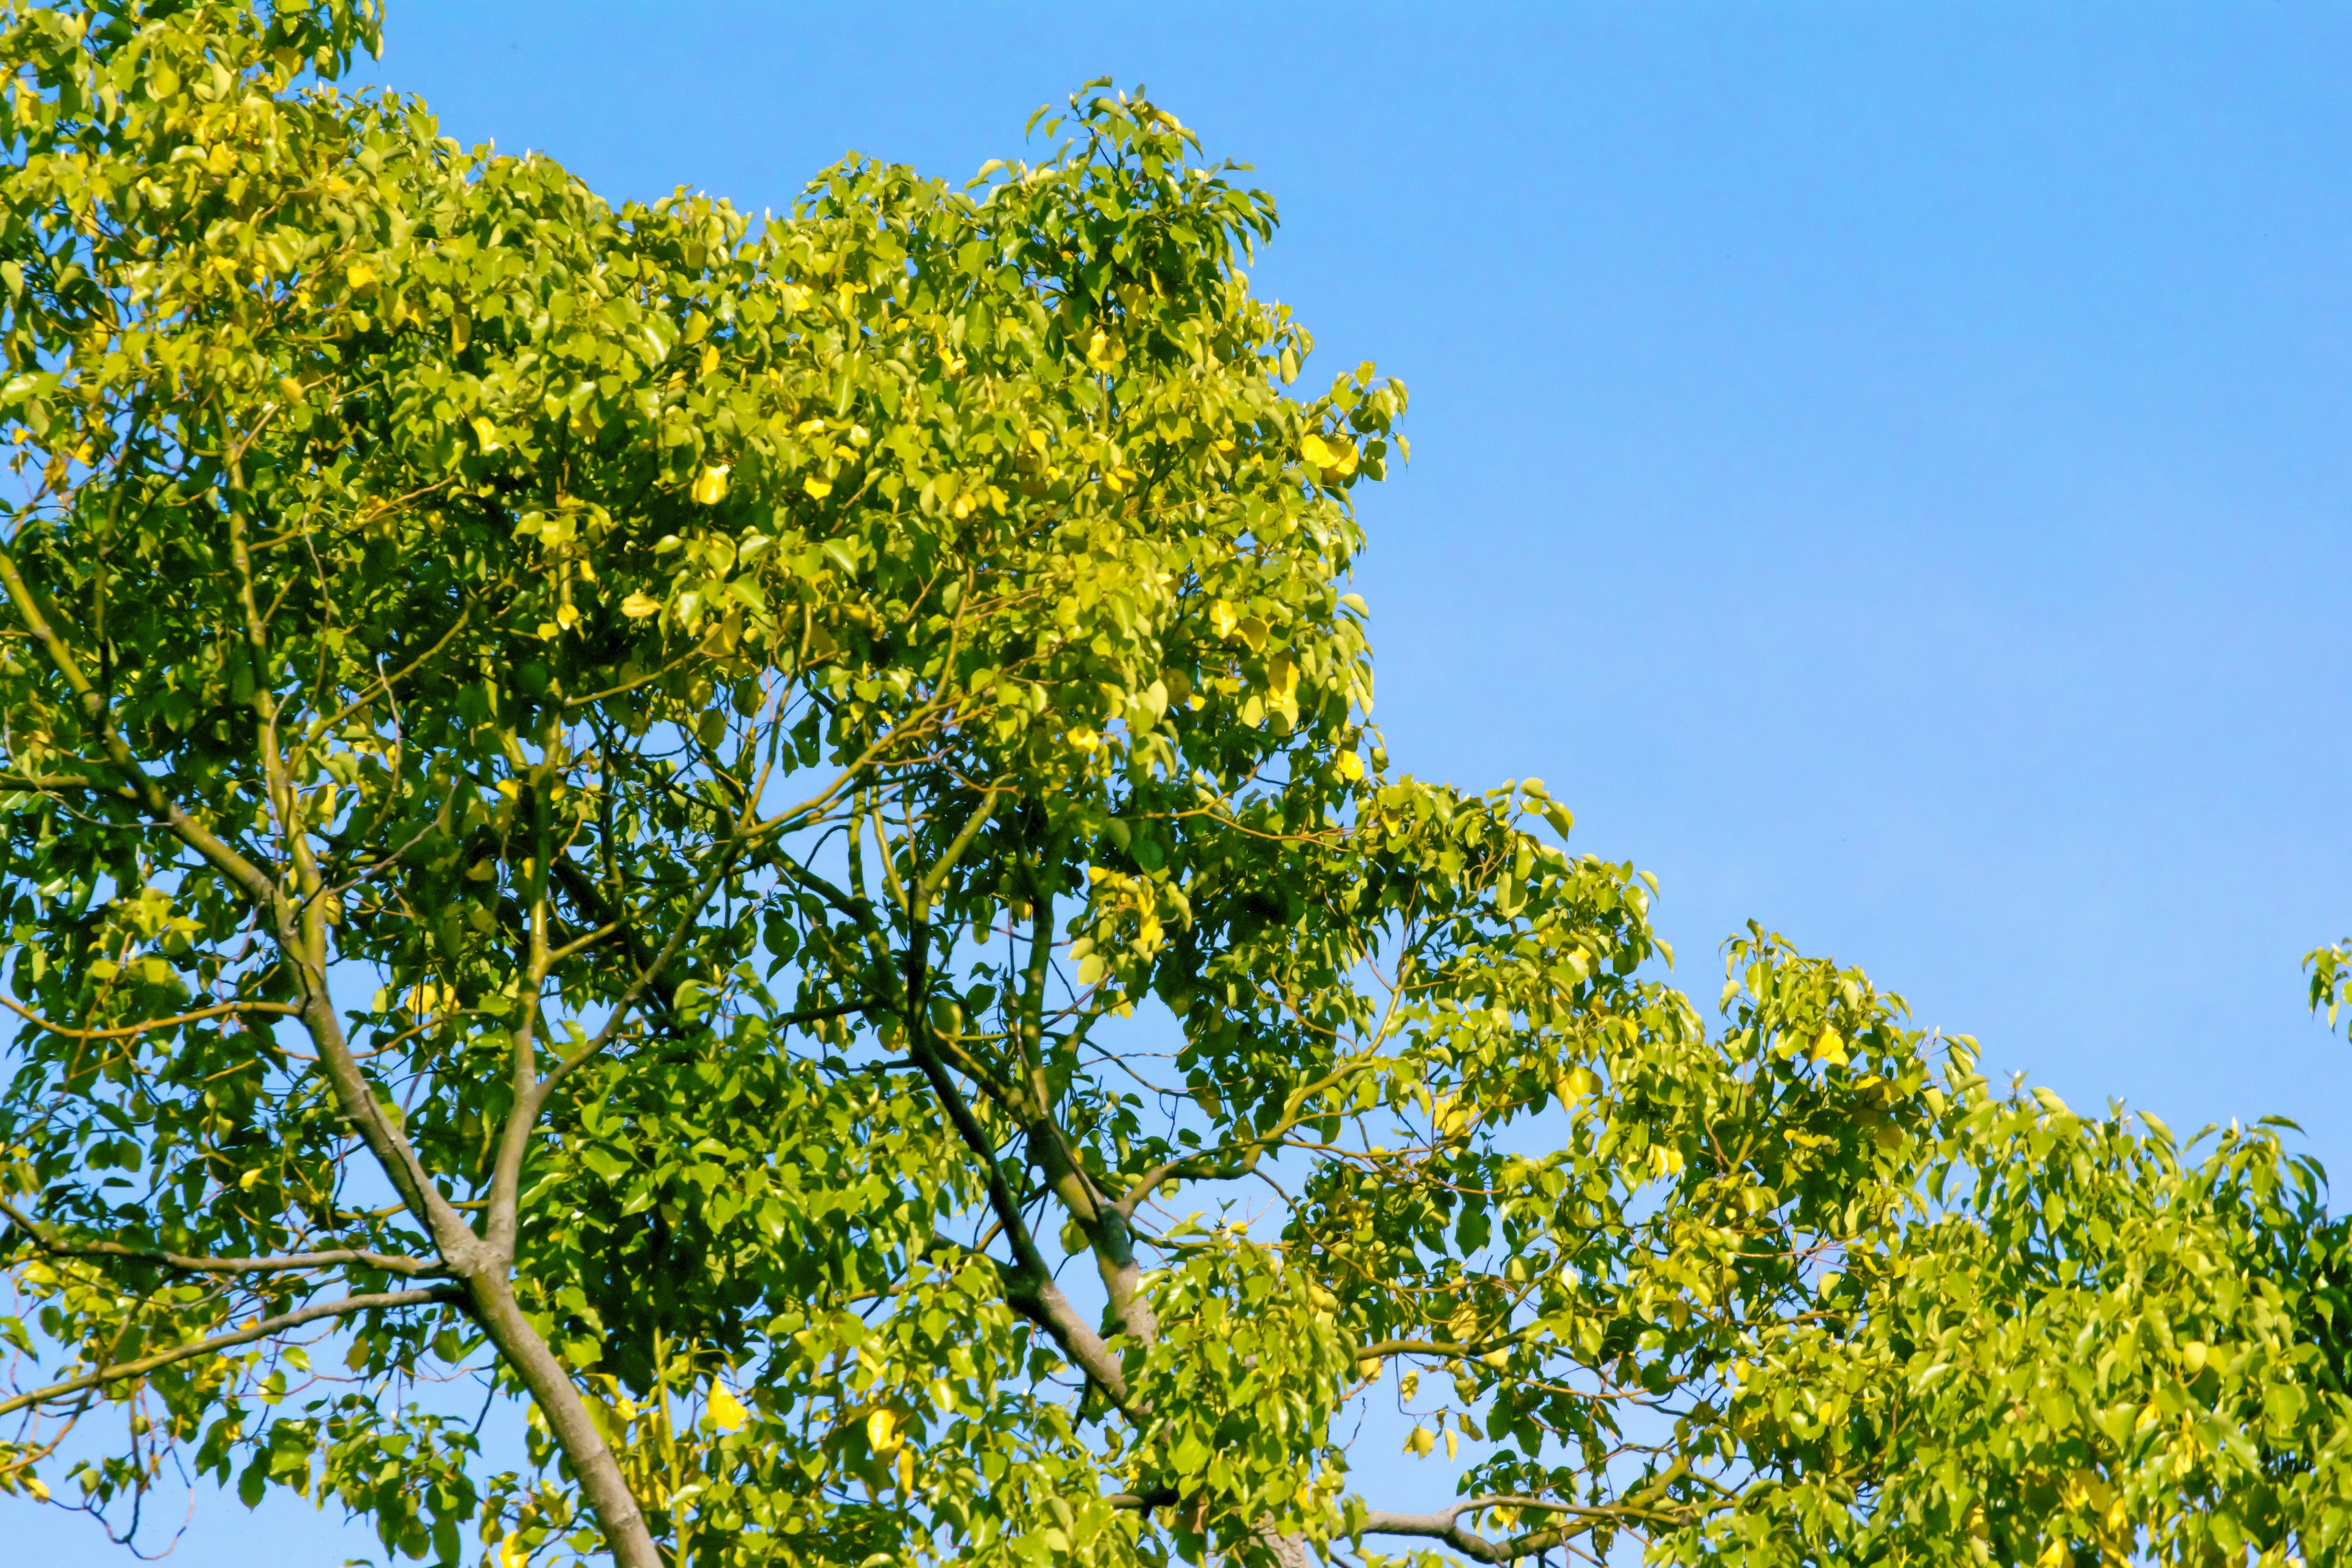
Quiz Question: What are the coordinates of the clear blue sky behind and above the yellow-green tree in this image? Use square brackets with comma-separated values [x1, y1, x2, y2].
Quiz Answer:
[32, 0, 2352, 1568]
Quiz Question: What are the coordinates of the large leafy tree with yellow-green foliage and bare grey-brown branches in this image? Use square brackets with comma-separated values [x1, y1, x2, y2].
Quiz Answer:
[0, 0, 2347, 1568]
